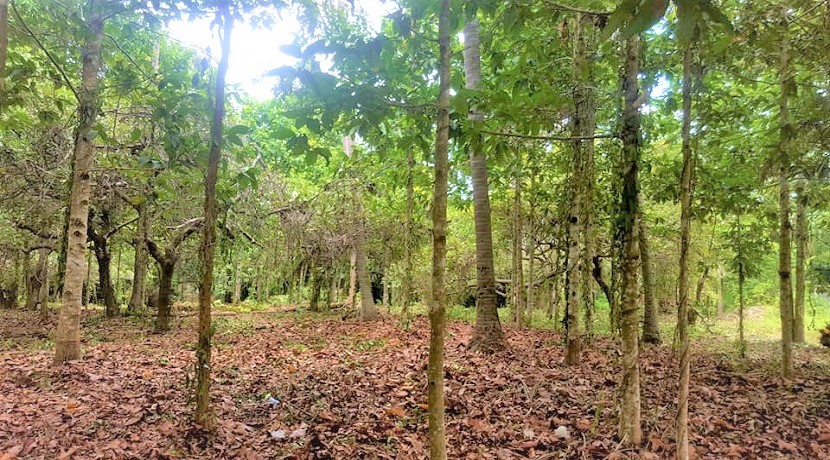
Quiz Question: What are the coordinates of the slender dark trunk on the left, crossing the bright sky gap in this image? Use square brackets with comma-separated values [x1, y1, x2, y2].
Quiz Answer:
[195, 0, 233, 428]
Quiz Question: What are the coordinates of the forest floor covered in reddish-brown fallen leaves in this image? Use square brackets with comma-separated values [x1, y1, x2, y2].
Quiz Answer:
[0, 310, 830, 460]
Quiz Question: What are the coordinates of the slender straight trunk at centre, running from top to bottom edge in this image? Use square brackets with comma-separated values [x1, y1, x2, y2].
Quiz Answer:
[427, 0, 452, 460]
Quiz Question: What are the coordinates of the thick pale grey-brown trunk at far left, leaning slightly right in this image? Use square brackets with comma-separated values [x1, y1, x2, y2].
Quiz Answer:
[54, 13, 104, 365]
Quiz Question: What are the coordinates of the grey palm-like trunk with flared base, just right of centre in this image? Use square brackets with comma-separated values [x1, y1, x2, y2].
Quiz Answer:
[464, 19, 504, 351]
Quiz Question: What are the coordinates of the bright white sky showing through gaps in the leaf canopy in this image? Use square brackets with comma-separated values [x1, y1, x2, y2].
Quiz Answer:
[169, 0, 394, 100]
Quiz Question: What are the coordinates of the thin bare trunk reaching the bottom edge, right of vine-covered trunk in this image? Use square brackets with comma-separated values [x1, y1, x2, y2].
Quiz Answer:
[675, 45, 693, 460]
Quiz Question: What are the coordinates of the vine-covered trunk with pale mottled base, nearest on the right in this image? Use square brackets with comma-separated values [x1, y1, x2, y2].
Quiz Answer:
[618, 35, 643, 446]
